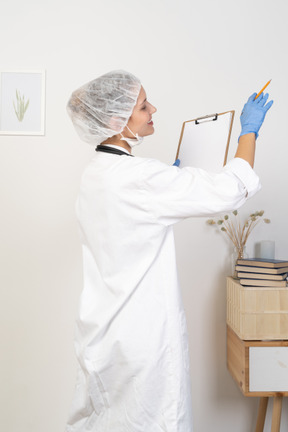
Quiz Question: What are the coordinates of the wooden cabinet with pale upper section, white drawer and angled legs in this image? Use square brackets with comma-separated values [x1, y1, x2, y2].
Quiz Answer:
[227, 277, 288, 432]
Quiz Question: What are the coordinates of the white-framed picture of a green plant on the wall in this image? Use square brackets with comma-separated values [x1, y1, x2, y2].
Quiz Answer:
[0, 71, 45, 135]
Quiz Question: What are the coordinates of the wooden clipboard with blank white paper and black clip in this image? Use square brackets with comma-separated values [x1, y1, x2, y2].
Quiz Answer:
[176, 111, 235, 172]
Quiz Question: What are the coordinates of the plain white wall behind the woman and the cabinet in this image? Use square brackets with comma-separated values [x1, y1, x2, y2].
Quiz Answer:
[0, 0, 288, 432]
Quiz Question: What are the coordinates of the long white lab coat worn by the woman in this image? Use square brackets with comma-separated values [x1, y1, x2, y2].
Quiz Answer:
[67, 149, 260, 432]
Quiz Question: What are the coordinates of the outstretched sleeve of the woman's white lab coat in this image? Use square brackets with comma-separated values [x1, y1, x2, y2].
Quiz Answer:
[142, 158, 261, 225]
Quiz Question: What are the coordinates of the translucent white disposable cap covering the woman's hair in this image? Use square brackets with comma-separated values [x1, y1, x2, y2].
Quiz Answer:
[67, 70, 141, 145]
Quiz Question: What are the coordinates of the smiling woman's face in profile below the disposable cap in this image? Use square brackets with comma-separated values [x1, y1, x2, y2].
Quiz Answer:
[124, 87, 157, 138]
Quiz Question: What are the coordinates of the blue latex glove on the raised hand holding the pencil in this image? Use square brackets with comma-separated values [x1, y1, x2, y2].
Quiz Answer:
[239, 93, 273, 138]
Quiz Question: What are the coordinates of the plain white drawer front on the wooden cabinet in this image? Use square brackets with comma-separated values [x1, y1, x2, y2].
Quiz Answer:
[249, 347, 288, 392]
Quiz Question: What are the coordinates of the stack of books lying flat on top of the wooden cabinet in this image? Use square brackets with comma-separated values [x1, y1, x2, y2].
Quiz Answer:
[236, 258, 288, 287]
